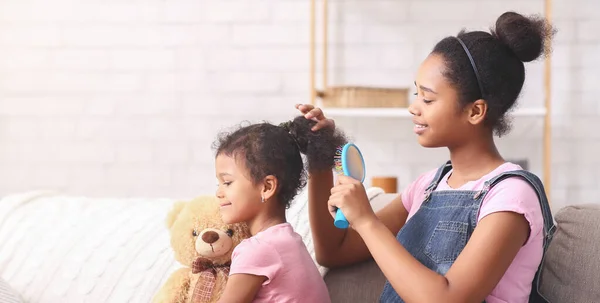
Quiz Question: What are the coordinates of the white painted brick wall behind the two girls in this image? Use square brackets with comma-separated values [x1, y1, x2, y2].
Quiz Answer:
[0, 0, 600, 211]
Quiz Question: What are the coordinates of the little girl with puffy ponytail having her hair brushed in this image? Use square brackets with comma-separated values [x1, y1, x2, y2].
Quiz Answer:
[215, 116, 345, 303]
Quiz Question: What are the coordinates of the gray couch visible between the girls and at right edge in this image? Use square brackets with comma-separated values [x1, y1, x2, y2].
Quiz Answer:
[325, 194, 600, 303]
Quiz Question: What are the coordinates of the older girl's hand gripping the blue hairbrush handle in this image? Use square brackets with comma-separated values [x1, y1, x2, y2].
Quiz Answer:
[327, 175, 377, 230]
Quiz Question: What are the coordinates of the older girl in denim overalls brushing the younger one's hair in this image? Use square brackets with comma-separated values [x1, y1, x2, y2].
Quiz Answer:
[297, 12, 554, 303]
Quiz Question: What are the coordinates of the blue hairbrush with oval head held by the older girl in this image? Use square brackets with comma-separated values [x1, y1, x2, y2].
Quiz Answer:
[333, 143, 366, 228]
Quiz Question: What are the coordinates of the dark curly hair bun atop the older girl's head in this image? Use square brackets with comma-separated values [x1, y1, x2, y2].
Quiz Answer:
[492, 12, 555, 62]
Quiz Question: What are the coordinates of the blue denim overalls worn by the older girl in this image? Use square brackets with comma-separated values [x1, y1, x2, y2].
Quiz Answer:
[380, 161, 555, 303]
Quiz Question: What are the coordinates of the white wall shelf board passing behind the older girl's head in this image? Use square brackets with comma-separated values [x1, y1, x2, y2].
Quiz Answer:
[322, 107, 546, 118]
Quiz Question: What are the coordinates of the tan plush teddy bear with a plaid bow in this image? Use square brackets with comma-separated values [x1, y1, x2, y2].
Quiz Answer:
[153, 196, 250, 303]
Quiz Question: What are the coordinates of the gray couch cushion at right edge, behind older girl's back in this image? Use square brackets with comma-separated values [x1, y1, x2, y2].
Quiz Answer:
[541, 204, 600, 303]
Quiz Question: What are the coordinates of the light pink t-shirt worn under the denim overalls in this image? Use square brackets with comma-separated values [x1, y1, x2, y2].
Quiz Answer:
[402, 162, 544, 303]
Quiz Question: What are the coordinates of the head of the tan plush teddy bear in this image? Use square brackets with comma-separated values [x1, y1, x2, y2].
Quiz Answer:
[166, 196, 250, 267]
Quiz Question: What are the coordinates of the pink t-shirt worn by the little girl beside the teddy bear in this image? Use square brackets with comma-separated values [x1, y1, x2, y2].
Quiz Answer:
[230, 223, 331, 303]
